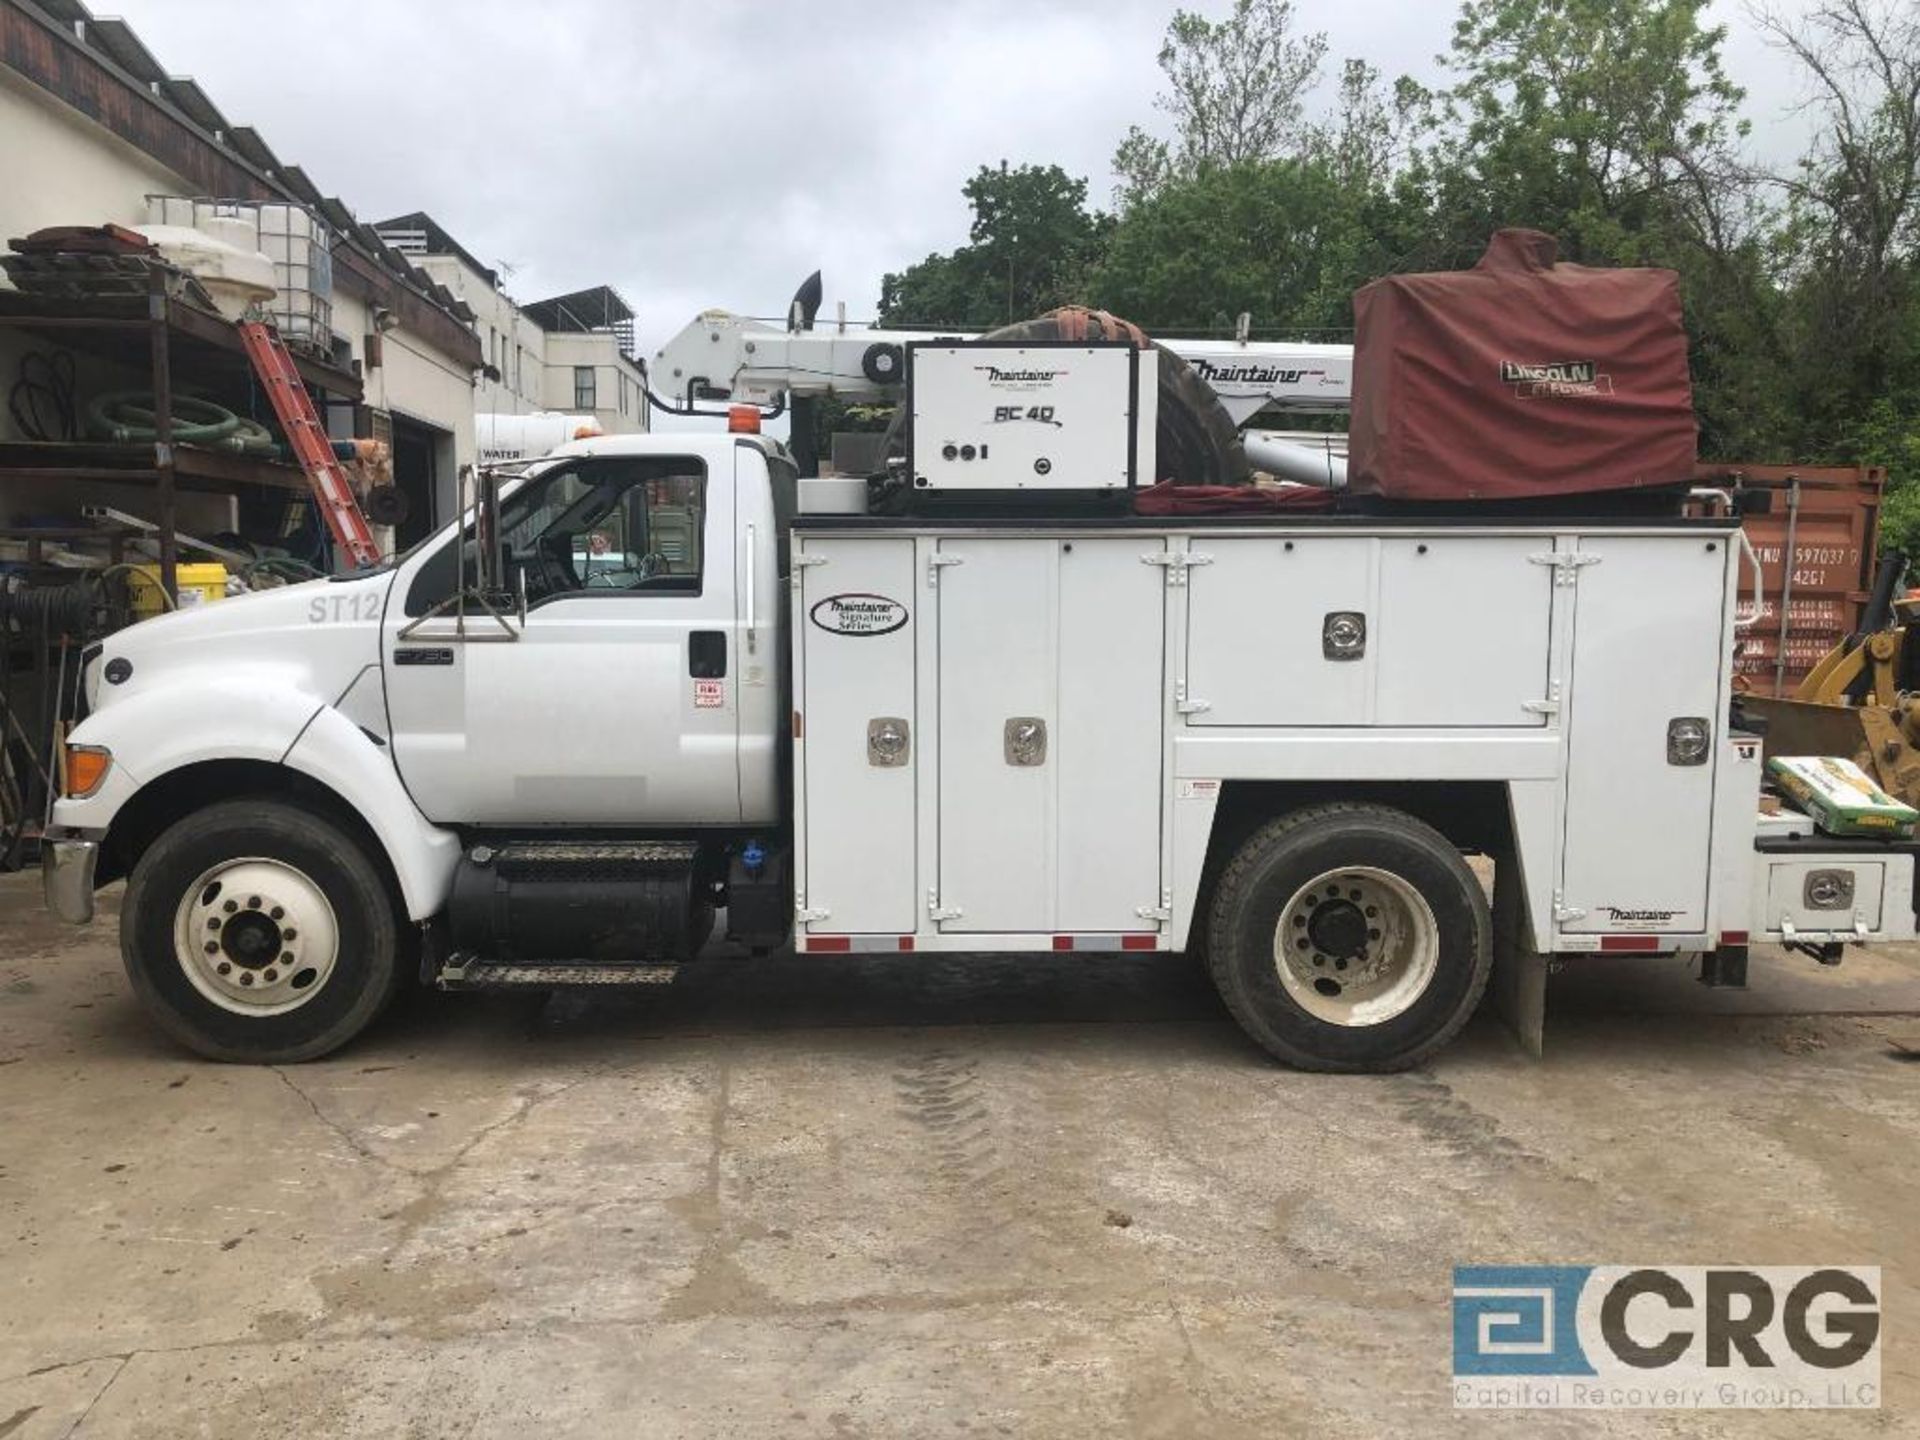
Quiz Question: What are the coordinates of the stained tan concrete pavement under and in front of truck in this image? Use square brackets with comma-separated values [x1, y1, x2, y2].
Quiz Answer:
[0, 877, 1920, 1440]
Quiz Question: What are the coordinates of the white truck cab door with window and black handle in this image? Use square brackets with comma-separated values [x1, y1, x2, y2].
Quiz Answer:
[382, 455, 739, 826]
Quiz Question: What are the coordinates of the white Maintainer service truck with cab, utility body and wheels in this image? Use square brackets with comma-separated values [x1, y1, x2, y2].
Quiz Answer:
[33, 342, 1914, 1069]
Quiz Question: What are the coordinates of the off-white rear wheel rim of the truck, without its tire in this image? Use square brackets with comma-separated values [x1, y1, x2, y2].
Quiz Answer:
[1273, 866, 1440, 1027]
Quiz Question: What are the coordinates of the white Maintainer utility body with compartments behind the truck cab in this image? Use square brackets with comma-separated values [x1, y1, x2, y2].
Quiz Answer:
[795, 518, 1912, 952]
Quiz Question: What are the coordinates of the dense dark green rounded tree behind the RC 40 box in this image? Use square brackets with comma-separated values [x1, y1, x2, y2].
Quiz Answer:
[879, 159, 1112, 330]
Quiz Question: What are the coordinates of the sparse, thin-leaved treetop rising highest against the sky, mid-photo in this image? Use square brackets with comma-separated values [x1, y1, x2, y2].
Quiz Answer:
[1114, 0, 1327, 204]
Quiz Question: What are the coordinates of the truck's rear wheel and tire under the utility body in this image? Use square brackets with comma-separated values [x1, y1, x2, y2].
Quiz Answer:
[1206, 804, 1494, 1071]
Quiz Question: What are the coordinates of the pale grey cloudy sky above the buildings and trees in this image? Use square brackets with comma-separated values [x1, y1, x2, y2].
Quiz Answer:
[108, 0, 1827, 348]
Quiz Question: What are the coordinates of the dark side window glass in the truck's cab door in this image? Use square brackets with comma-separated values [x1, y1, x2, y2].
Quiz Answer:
[407, 457, 707, 614]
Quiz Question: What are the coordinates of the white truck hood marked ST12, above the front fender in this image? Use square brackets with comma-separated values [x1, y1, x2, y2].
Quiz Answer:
[84, 570, 394, 710]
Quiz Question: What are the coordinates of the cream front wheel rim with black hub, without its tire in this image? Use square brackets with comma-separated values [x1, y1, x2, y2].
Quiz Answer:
[173, 856, 340, 1016]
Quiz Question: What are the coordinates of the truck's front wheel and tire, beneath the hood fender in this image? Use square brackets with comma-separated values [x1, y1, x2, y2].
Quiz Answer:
[121, 799, 401, 1064]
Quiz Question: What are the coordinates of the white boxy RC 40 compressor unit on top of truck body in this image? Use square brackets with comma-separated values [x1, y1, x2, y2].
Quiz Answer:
[906, 340, 1158, 499]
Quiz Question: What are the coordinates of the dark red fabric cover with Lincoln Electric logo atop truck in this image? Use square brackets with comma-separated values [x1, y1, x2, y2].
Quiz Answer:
[1346, 230, 1695, 499]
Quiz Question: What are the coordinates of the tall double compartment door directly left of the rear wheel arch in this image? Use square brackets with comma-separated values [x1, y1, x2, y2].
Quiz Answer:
[937, 536, 1165, 933]
